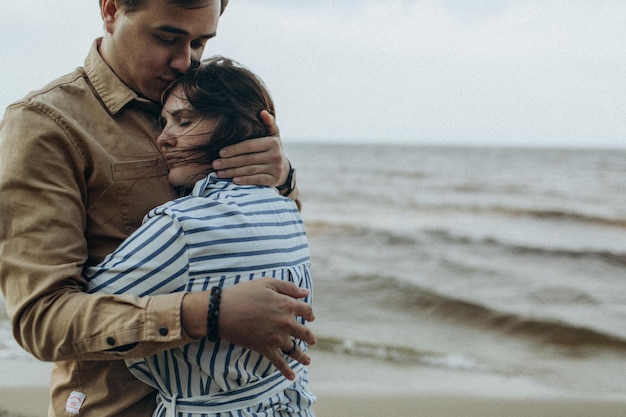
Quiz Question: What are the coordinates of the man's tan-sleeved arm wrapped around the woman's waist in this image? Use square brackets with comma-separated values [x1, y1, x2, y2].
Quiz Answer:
[0, 104, 189, 361]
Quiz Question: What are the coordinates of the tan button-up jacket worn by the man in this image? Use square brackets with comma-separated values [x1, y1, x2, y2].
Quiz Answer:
[0, 41, 195, 417]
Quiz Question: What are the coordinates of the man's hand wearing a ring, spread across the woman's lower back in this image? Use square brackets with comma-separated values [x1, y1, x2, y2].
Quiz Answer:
[219, 278, 316, 380]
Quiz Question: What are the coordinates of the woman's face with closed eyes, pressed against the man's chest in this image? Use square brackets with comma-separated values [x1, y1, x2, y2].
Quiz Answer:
[157, 87, 217, 187]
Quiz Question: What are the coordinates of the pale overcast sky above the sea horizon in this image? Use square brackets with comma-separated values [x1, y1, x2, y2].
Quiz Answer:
[0, 0, 626, 147]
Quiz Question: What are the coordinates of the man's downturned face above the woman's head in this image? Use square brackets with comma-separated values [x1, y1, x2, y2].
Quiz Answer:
[100, 0, 220, 101]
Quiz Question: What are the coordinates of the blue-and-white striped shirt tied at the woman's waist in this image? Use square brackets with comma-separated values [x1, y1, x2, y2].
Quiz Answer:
[85, 174, 315, 417]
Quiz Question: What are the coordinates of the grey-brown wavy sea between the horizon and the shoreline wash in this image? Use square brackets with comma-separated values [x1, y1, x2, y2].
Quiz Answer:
[0, 142, 626, 398]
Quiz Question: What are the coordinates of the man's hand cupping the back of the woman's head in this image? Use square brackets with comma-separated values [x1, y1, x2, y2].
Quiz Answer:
[213, 110, 289, 187]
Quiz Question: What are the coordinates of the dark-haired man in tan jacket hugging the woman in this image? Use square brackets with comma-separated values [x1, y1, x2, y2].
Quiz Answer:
[0, 0, 315, 417]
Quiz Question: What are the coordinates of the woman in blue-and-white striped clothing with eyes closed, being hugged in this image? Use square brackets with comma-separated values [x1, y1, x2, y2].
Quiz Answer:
[85, 57, 315, 417]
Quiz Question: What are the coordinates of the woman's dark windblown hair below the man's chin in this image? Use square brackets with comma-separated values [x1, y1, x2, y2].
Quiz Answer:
[161, 56, 275, 170]
